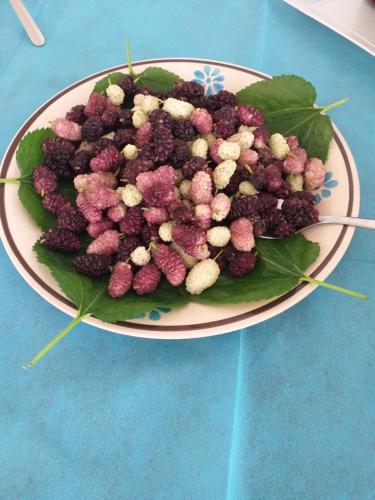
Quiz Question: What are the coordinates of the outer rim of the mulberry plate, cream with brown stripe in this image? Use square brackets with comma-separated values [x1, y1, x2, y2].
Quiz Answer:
[0, 57, 360, 340]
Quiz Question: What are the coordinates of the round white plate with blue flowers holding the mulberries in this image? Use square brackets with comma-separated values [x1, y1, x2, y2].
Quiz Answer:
[0, 59, 359, 339]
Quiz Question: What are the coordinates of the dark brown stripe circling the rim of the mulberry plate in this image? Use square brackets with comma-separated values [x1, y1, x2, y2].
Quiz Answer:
[0, 58, 354, 331]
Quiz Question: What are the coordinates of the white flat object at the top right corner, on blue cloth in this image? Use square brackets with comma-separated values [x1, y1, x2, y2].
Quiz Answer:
[284, 0, 375, 55]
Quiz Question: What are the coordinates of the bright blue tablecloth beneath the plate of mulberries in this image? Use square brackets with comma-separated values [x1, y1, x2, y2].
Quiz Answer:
[0, 0, 375, 500]
